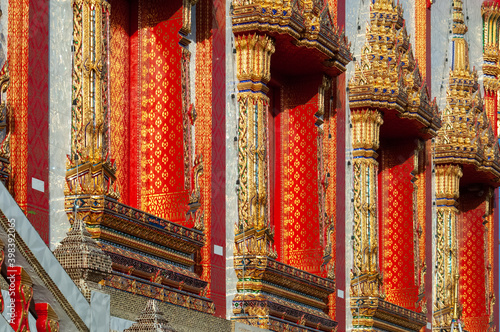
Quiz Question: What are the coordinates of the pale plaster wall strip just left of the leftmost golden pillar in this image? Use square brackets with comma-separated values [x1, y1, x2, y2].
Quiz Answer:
[49, 0, 73, 249]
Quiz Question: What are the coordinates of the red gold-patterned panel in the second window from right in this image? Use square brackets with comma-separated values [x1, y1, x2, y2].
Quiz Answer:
[379, 142, 418, 310]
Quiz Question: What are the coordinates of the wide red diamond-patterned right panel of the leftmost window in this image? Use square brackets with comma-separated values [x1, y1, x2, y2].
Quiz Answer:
[137, 0, 188, 223]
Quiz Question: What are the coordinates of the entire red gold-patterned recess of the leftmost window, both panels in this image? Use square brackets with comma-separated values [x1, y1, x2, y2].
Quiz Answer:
[110, 0, 188, 223]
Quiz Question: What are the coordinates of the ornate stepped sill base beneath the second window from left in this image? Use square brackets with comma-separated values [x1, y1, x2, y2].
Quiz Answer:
[233, 255, 337, 331]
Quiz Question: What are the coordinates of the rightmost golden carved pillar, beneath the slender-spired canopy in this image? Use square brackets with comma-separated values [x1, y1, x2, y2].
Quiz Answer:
[433, 164, 463, 331]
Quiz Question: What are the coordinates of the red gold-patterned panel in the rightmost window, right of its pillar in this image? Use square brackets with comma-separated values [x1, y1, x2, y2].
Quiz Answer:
[459, 190, 489, 332]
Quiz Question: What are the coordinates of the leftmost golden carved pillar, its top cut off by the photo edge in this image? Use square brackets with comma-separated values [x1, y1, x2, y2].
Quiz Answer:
[65, 0, 119, 221]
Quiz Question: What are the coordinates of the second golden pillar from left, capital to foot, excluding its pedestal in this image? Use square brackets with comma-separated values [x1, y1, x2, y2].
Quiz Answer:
[235, 34, 274, 255]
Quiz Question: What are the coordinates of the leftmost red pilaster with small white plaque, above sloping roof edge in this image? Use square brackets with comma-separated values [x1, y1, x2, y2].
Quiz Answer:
[7, 0, 49, 244]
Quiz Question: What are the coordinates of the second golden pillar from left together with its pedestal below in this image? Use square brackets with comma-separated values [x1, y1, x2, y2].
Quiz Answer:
[233, 33, 277, 328]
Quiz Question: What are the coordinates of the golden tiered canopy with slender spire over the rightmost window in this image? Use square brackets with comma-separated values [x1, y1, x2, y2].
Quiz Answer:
[435, 0, 500, 186]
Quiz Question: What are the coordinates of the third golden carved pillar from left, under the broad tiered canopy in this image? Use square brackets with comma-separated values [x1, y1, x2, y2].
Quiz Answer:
[351, 109, 383, 298]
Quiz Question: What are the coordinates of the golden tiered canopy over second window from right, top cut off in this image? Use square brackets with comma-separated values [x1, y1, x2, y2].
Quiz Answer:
[349, 0, 441, 137]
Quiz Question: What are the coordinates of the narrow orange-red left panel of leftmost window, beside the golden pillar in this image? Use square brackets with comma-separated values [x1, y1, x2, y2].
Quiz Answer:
[109, 0, 130, 206]
